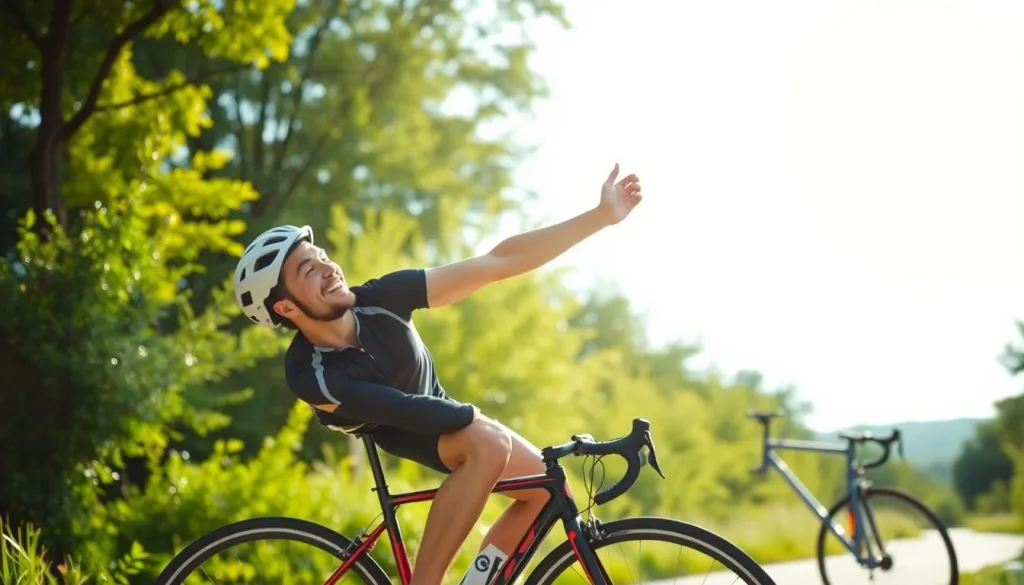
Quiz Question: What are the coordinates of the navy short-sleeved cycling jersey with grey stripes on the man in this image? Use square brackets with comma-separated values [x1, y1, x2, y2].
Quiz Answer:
[285, 269, 473, 434]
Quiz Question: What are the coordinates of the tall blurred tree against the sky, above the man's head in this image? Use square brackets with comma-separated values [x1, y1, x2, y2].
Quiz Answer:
[131, 0, 566, 319]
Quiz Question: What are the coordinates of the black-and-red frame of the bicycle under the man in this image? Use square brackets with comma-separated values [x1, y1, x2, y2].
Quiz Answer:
[326, 435, 609, 585]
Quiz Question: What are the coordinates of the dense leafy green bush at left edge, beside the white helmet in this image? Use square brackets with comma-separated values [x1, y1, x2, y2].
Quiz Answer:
[0, 156, 286, 569]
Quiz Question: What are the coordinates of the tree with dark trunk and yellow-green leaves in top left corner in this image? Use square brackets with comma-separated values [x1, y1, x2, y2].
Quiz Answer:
[0, 0, 294, 237]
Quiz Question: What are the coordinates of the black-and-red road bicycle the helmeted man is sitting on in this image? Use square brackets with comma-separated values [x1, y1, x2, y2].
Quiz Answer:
[157, 419, 774, 585]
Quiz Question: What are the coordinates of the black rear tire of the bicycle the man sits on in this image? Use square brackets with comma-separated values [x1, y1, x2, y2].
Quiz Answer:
[156, 516, 391, 585]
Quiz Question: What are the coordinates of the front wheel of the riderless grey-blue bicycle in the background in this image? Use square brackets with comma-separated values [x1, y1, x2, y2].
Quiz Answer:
[817, 487, 959, 585]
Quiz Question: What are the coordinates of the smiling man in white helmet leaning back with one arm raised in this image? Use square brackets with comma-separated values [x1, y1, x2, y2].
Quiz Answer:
[233, 164, 641, 585]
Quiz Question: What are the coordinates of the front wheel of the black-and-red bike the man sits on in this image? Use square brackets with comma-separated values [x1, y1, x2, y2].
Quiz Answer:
[525, 517, 775, 585]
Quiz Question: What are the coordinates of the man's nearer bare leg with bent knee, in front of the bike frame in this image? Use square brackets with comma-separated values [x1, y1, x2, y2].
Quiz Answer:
[410, 415, 512, 585]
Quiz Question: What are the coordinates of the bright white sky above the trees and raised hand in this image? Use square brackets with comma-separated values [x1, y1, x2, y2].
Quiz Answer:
[487, 0, 1024, 430]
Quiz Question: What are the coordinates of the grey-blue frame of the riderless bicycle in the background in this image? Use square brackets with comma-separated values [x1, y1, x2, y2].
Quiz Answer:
[755, 434, 881, 569]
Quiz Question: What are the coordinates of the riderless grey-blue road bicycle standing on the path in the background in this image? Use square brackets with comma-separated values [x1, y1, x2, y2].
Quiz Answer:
[748, 411, 959, 585]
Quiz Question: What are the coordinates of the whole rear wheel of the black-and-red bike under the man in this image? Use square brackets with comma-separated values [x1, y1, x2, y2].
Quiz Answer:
[156, 517, 391, 585]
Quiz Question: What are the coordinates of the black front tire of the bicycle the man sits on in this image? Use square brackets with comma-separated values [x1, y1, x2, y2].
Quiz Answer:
[524, 516, 775, 585]
